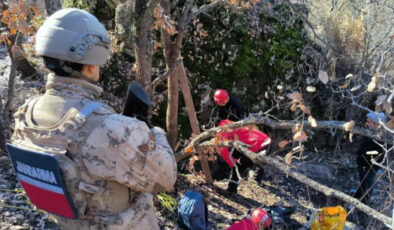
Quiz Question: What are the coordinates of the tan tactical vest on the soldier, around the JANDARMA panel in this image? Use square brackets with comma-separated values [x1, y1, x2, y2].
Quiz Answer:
[11, 97, 138, 225]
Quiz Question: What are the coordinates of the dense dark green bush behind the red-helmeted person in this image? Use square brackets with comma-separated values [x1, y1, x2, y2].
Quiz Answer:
[183, 6, 308, 110]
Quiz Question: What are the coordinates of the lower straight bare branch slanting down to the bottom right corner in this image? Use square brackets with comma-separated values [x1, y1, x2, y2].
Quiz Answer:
[200, 141, 394, 229]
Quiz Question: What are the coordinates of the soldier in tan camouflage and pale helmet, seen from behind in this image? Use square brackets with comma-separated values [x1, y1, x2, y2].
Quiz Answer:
[12, 9, 176, 230]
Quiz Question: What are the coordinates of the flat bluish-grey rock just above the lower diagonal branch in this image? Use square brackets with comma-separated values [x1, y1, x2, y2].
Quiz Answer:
[297, 163, 335, 181]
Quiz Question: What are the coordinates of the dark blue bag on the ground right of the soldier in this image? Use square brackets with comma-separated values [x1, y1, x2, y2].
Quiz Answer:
[178, 191, 208, 230]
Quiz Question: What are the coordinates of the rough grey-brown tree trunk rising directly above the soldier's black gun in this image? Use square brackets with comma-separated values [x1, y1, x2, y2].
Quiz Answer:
[134, 0, 154, 96]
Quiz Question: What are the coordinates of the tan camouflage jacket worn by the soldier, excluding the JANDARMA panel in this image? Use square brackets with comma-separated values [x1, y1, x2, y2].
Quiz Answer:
[12, 75, 176, 230]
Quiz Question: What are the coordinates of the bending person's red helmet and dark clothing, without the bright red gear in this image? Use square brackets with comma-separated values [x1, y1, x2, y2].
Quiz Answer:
[212, 89, 263, 193]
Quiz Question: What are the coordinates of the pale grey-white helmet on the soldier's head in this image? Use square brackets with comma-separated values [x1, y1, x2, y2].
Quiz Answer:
[36, 8, 111, 65]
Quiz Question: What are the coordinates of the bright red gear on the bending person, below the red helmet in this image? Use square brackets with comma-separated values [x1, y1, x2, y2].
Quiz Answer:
[219, 120, 271, 167]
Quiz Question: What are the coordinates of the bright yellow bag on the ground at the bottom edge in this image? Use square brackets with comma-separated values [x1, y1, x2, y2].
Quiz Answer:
[311, 206, 346, 230]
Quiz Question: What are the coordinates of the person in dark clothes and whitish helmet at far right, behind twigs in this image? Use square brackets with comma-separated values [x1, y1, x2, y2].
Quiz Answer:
[354, 112, 387, 204]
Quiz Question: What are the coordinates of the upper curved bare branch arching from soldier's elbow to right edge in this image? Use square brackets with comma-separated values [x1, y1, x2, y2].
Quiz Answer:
[176, 115, 394, 161]
